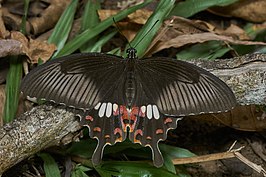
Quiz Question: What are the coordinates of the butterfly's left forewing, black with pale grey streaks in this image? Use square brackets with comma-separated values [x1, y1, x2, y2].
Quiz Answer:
[21, 53, 126, 110]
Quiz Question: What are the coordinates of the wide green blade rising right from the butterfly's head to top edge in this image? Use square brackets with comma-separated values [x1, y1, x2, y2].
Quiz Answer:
[127, 0, 175, 58]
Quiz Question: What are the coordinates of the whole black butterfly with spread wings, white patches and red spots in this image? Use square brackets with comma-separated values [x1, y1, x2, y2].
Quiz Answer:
[21, 48, 236, 167]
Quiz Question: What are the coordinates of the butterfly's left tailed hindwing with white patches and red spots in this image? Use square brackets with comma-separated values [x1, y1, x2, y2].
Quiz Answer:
[81, 102, 127, 165]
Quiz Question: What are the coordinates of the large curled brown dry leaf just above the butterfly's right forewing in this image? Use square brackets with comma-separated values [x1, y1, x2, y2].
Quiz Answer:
[145, 17, 256, 56]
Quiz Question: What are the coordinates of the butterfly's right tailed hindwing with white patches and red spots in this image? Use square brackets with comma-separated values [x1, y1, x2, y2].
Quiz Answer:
[129, 105, 181, 167]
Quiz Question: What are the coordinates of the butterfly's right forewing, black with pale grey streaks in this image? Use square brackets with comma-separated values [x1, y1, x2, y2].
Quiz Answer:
[136, 57, 236, 116]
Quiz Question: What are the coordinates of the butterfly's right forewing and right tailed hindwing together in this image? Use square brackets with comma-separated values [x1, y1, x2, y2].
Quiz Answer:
[125, 58, 236, 167]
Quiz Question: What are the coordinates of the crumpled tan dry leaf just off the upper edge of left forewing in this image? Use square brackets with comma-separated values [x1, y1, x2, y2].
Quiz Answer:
[11, 31, 56, 63]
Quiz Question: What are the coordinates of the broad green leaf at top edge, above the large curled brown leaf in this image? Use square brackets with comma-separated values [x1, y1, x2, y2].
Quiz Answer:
[170, 0, 238, 17]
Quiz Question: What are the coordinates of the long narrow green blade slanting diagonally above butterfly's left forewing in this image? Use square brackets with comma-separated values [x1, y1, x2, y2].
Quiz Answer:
[56, 0, 152, 57]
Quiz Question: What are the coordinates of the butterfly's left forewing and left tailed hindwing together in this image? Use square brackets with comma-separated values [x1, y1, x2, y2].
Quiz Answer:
[21, 53, 131, 164]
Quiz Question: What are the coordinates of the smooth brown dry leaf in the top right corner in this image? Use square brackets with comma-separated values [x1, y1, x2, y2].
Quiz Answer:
[210, 0, 266, 22]
